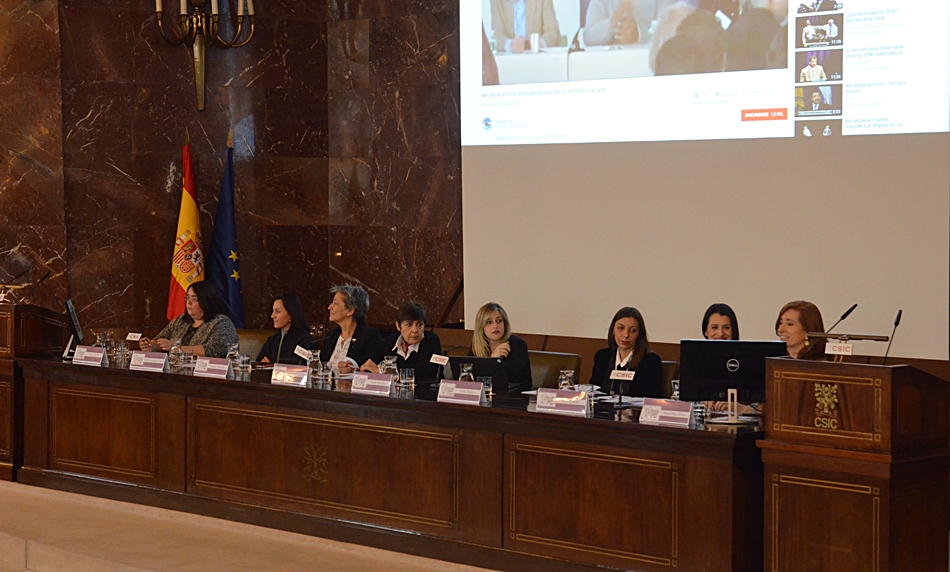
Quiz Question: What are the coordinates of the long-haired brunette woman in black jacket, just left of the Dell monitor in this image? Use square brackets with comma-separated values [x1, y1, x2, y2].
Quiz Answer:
[590, 306, 666, 398]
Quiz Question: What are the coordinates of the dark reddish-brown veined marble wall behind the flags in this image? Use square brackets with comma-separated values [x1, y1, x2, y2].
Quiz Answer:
[0, 0, 462, 330]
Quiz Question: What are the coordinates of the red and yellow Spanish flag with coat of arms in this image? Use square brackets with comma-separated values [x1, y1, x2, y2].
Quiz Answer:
[165, 144, 205, 320]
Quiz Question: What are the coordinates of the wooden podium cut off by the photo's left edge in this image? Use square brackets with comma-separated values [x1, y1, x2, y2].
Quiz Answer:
[0, 303, 68, 481]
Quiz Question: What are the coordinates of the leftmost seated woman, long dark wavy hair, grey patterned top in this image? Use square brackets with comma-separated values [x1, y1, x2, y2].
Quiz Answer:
[139, 282, 238, 357]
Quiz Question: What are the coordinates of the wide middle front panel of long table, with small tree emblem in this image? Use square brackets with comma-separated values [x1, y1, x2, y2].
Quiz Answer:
[188, 399, 478, 538]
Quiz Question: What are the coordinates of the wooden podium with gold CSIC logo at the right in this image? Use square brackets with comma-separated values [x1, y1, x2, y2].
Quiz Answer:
[759, 358, 950, 572]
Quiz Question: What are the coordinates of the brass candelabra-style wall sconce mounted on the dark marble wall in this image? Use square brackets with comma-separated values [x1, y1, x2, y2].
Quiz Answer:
[155, 0, 254, 111]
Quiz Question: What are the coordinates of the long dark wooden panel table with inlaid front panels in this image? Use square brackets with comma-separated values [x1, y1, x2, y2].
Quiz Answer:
[17, 360, 763, 571]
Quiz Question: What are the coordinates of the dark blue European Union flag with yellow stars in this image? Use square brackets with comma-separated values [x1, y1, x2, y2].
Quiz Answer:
[205, 141, 244, 328]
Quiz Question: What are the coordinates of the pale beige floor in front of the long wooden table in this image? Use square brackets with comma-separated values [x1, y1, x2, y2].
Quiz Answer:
[0, 482, 494, 572]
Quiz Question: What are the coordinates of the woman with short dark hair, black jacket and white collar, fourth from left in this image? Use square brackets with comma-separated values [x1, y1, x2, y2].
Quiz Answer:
[361, 302, 442, 381]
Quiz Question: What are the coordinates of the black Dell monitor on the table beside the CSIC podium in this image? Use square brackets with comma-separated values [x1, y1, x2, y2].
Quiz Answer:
[680, 340, 788, 403]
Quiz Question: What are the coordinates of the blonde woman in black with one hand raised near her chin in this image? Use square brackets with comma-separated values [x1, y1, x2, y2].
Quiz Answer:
[469, 302, 531, 395]
